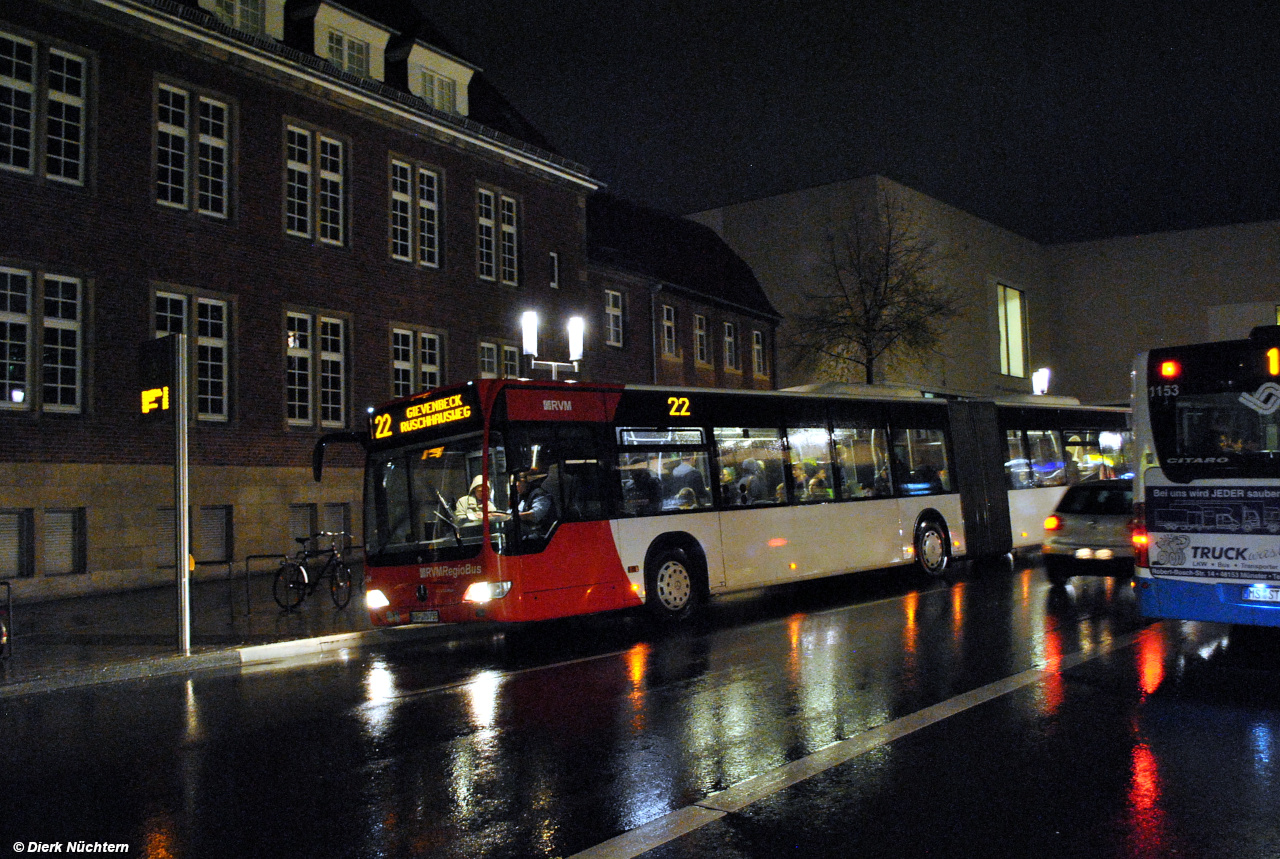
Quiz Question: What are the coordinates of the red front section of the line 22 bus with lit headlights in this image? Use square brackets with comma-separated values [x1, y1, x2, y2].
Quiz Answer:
[365, 380, 640, 626]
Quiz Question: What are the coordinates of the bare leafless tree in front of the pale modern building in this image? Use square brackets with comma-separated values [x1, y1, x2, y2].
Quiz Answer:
[792, 188, 963, 384]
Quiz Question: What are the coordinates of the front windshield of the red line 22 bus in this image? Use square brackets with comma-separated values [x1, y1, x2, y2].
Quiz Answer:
[365, 433, 506, 563]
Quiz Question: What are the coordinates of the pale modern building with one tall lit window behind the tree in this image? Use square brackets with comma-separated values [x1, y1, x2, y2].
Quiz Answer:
[690, 177, 1280, 403]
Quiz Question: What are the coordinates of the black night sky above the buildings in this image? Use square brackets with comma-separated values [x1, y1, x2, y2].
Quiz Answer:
[404, 0, 1280, 242]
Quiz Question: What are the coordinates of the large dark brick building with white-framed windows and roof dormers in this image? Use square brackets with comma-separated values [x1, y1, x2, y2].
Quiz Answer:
[0, 0, 778, 599]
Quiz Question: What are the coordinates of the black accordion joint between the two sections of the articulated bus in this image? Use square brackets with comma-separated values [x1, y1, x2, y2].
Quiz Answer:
[947, 399, 1014, 557]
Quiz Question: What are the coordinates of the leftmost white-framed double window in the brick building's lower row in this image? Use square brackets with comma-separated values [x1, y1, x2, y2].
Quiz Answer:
[0, 268, 84, 412]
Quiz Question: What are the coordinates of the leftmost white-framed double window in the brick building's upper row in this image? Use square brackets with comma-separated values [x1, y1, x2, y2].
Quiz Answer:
[0, 32, 88, 184]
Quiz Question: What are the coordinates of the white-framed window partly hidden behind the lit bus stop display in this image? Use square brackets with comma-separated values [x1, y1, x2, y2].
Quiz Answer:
[155, 292, 230, 421]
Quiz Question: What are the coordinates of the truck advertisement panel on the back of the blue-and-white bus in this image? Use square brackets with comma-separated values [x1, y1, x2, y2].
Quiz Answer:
[1146, 486, 1280, 581]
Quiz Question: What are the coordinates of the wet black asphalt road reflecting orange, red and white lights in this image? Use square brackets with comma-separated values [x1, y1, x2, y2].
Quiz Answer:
[0, 563, 1280, 859]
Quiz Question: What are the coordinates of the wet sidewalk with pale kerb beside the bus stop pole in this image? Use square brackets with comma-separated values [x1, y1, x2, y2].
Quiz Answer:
[0, 574, 430, 700]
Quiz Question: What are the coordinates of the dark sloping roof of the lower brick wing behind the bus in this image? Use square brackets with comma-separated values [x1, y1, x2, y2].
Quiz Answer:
[586, 192, 782, 320]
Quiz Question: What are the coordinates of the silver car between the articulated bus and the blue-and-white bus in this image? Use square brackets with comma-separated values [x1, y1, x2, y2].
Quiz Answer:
[1041, 480, 1133, 585]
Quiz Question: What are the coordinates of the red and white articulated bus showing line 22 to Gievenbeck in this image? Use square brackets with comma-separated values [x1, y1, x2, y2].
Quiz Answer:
[315, 379, 1128, 626]
